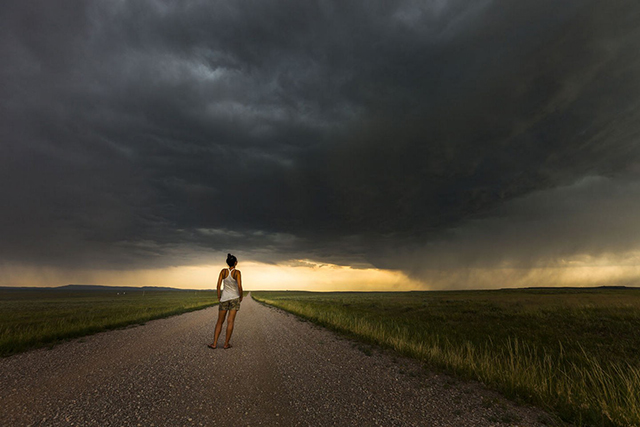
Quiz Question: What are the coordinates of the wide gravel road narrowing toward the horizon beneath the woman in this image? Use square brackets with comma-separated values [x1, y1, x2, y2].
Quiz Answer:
[0, 298, 548, 426]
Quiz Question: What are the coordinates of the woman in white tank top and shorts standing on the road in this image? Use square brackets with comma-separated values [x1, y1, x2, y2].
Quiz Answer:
[208, 254, 242, 350]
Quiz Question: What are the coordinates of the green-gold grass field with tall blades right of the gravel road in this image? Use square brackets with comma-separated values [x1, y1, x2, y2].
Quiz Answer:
[252, 288, 640, 426]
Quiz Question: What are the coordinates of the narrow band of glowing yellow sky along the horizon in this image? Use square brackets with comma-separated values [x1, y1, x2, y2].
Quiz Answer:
[0, 253, 640, 292]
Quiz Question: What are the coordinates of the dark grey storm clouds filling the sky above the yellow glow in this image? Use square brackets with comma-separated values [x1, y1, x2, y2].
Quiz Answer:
[0, 0, 640, 288]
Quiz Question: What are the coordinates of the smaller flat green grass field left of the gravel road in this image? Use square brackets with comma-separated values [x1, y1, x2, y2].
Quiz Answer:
[0, 290, 218, 356]
